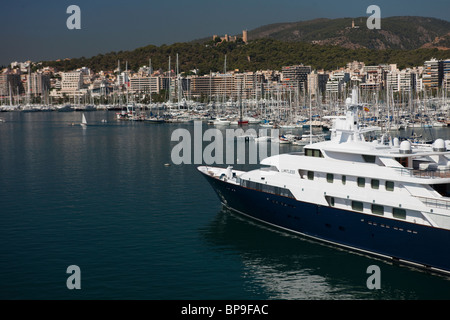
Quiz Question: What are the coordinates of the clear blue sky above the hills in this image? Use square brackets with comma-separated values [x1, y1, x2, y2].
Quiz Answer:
[0, 0, 450, 65]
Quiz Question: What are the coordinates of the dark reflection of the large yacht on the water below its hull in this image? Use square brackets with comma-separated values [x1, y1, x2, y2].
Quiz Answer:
[204, 209, 450, 300]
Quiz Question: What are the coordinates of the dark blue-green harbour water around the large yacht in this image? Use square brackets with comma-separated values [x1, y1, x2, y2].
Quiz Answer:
[0, 111, 450, 300]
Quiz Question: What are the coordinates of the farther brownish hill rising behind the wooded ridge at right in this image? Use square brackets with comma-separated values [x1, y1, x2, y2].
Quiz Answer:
[248, 16, 450, 50]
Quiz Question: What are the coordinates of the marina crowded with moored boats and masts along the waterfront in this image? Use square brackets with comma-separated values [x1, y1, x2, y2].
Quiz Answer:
[0, 85, 450, 145]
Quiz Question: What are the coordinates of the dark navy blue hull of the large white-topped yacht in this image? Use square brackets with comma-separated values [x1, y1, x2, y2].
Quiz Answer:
[203, 170, 450, 273]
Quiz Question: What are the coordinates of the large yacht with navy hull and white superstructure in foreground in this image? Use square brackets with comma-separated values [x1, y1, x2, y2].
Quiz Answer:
[198, 91, 450, 273]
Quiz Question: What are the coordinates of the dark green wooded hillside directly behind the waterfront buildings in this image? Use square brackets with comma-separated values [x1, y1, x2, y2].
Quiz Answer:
[42, 38, 450, 74]
